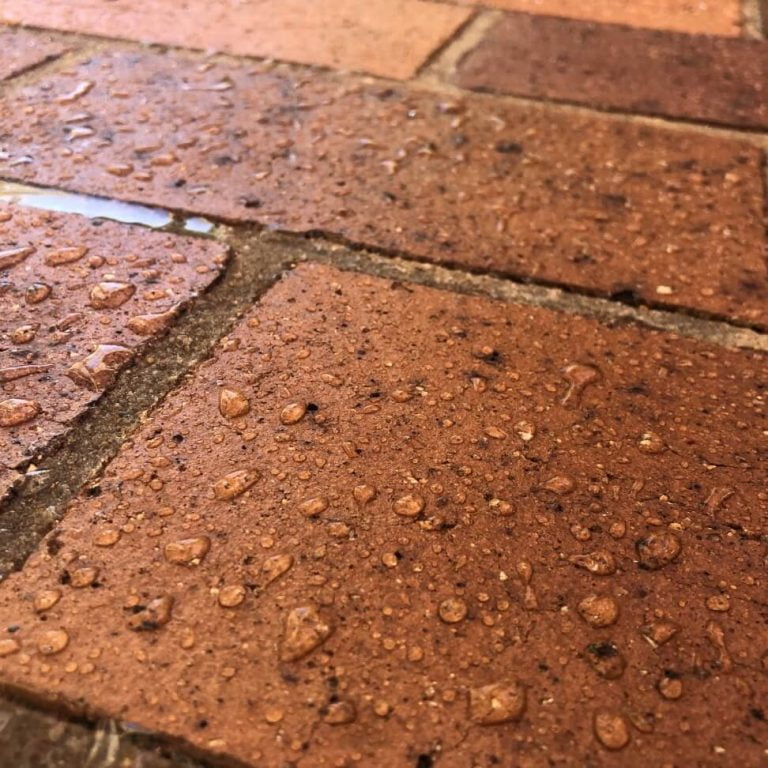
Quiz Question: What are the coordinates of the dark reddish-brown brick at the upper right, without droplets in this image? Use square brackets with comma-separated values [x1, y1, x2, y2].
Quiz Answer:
[456, 14, 768, 129]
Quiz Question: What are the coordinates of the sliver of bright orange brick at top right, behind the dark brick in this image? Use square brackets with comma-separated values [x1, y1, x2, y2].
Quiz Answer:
[460, 0, 741, 36]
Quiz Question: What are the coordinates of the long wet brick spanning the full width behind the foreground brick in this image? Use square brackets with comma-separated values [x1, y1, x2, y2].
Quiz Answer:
[0, 52, 768, 326]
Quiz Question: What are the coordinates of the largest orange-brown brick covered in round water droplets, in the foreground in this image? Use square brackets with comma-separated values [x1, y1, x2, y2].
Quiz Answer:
[0, 265, 768, 768]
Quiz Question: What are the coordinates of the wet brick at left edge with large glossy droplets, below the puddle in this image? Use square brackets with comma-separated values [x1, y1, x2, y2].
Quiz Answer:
[0, 205, 225, 504]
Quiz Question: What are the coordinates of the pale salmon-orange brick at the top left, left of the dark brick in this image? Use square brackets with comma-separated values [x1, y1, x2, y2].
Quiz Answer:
[0, 0, 471, 79]
